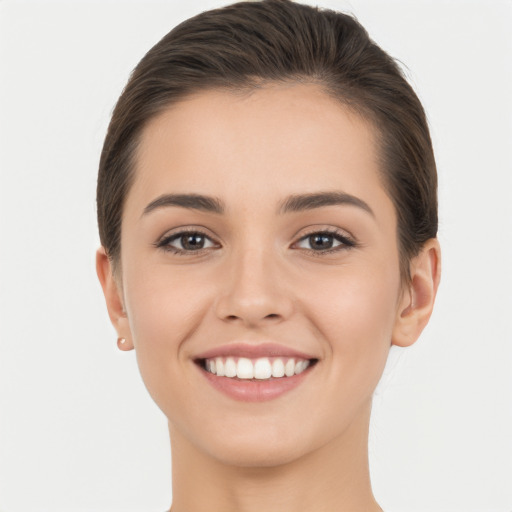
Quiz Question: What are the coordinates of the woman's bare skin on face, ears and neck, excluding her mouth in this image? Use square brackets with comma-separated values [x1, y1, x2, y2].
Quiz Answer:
[97, 84, 440, 512]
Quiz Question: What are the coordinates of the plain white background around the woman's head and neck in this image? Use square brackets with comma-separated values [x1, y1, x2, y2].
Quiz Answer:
[0, 0, 512, 512]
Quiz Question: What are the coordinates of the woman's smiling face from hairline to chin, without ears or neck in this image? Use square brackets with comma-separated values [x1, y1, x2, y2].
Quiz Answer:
[116, 84, 404, 465]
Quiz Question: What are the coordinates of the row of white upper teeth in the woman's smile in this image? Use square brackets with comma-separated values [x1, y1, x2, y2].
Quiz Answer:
[206, 357, 310, 379]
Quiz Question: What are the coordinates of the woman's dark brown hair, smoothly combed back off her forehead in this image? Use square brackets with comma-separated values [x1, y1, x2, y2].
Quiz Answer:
[97, 0, 437, 279]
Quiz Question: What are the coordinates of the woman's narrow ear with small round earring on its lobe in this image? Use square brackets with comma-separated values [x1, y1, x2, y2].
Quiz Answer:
[96, 247, 133, 350]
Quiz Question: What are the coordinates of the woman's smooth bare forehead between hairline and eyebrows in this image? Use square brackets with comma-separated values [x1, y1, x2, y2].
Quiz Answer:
[130, 84, 383, 216]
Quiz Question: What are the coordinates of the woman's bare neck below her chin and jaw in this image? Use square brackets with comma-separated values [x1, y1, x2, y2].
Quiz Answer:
[169, 408, 381, 512]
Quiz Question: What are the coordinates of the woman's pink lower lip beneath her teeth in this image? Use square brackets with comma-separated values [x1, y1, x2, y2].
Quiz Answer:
[199, 365, 315, 402]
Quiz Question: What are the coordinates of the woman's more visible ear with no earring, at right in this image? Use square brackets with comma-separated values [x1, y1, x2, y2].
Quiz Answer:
[391, 238, 441, 347]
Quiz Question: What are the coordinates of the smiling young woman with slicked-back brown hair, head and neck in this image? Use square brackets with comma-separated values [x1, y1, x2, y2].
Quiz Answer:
[97, 0, 440, 512]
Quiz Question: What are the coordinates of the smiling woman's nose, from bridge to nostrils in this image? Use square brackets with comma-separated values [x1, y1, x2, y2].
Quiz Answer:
[215, 245, 293, 328]
